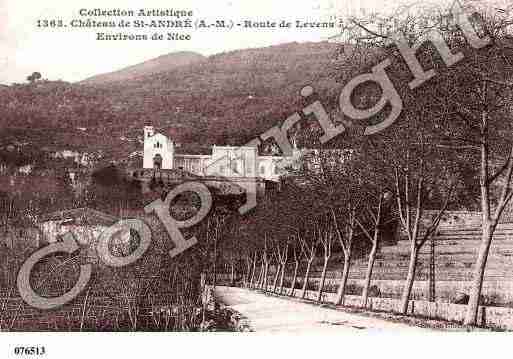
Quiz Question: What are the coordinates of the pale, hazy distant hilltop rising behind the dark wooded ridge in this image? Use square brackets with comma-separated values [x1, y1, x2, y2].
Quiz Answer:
[81, 52, 206, 85]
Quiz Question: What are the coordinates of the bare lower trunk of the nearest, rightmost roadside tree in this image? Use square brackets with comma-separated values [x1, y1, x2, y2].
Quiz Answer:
[465, 223, 495, 325]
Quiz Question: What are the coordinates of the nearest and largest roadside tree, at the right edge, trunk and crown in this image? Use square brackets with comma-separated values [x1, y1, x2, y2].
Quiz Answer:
[451, 20, 513, 325]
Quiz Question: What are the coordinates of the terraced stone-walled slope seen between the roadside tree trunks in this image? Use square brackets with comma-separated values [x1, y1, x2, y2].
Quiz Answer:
[336, 224, 513, 305]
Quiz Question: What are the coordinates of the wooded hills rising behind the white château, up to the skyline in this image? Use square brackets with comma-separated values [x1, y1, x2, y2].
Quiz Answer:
[0, 42, 341, 159]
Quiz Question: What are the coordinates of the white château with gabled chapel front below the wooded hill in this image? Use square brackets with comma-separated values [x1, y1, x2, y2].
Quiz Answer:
[143, 126, 299, 181]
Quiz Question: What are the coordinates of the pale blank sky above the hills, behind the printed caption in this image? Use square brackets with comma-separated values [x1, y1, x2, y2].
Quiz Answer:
[0, 0, 444, 84]
